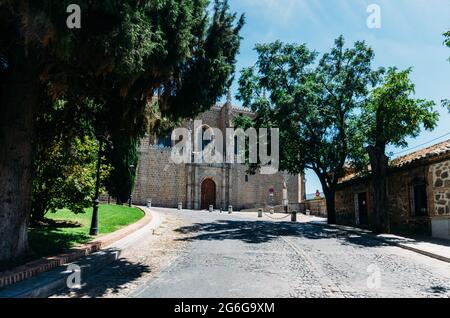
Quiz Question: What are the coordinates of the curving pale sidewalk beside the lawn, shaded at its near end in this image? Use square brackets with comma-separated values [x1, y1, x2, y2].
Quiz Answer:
[0, 207, 161, 298]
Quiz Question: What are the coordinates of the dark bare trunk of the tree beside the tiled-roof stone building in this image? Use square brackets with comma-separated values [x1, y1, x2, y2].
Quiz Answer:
[367, 144, 390, 233]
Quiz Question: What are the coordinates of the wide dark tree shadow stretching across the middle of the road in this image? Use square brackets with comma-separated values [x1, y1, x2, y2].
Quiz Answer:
[172, 220, 394, 247]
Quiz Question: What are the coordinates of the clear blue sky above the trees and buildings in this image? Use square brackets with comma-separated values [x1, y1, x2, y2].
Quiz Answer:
[230, 0, 450, 193]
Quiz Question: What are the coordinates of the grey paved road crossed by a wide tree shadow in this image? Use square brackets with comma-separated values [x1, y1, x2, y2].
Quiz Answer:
[129, 208, 450, 298]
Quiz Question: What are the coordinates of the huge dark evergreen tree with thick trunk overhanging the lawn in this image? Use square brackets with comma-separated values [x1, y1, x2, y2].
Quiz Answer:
[0, 0, 243, 261]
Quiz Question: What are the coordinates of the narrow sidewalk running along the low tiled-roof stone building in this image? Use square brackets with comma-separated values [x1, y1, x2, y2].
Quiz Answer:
[310, 216, 450, 263]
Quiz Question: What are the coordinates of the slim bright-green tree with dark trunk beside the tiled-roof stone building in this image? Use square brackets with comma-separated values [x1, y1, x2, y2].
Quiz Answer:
[358, 68, 439, 232]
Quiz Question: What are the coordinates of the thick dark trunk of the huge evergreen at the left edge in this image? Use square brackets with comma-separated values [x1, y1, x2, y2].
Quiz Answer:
[0, 54, 38, 262]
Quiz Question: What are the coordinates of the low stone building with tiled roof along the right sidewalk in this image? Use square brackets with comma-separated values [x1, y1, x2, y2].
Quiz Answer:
[336, 140, 450, 239]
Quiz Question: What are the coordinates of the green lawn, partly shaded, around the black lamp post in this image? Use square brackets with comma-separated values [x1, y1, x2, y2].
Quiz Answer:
[29, 204, 144, 257]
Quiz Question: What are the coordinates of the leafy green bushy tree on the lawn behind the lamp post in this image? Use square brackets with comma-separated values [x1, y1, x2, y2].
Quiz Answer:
[31, 136, 106, 222]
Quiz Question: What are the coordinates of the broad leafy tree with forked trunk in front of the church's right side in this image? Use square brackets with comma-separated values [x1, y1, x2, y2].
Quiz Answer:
[238, 37, 378, 223]
